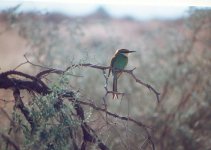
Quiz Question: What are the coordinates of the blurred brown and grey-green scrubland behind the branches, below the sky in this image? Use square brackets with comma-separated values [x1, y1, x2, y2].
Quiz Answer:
[0, 3, 211, 150]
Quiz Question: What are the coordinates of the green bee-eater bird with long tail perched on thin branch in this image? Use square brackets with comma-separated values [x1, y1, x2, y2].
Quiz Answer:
[108, 49, 135, 99]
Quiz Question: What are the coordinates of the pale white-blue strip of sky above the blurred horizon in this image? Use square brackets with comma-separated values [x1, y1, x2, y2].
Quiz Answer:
[0, 0, 211, 20]
